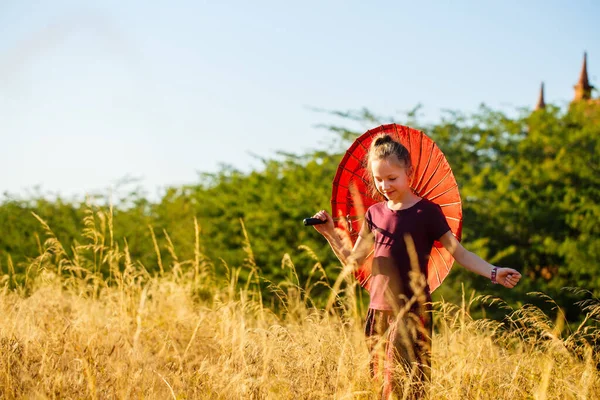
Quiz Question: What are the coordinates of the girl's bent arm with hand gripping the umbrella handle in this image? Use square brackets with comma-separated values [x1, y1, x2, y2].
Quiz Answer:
[314, 210, 373, 267]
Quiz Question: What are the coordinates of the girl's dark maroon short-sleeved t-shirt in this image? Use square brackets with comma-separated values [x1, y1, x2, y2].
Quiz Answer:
[365, 199, 450, 310]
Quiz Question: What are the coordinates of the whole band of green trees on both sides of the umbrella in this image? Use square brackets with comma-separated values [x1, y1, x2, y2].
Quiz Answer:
[0, 103, 600, 322]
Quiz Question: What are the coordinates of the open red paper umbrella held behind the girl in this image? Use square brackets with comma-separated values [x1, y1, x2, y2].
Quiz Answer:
[331, 124, 462, 291]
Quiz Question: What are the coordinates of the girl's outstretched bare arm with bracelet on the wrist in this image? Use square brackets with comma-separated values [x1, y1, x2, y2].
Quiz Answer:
[439, 231, 521, 288]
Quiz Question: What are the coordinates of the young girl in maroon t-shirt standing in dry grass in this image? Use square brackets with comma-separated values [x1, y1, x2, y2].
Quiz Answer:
[314, 134, 521, 398]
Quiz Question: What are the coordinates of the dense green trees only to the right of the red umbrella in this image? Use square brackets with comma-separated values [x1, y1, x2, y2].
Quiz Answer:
[430, 103, 600, 312]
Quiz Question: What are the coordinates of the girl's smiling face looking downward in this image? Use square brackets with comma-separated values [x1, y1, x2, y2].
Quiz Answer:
[371, 156, 412, 200]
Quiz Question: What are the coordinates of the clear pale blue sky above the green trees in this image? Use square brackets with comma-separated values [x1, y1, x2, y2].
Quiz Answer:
[0, 0, 600, 203]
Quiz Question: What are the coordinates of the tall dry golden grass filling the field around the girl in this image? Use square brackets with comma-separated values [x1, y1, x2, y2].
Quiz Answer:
[0, 210, 600, 399]
